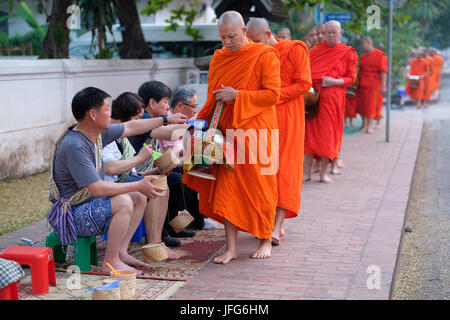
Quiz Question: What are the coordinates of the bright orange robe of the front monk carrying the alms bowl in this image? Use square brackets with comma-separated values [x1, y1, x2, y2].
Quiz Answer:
[183, 40, 281, 239]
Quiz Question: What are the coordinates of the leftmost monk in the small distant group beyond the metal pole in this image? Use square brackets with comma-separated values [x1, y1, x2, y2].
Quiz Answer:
[405, 50, 428, 109]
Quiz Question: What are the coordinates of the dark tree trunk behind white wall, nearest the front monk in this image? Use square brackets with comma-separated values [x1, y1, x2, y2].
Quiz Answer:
[118, 0, 152, 59]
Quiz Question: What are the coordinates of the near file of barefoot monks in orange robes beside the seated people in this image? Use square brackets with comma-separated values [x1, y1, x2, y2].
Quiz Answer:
[183, 11, 442, 264]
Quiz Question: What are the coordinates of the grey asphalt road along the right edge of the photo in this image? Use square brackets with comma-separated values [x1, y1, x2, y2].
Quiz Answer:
[391, 75, 450, 300]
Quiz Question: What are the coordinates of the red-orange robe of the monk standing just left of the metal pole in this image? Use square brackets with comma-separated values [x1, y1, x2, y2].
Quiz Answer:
[356, 48, 388, 119]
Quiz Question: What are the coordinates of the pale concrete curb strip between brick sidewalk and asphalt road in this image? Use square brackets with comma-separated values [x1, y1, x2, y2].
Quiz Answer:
[346, 114, 424, 300]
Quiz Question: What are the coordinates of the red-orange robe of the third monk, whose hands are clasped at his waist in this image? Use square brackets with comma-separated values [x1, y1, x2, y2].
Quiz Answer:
[305, 42, 358, 160]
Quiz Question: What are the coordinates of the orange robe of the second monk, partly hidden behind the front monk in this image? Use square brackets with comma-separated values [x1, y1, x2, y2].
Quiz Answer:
[274, 38, 312, 218]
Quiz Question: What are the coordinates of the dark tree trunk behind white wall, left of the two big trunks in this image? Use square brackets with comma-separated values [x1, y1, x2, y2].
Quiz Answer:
[42, 0, 72, 59]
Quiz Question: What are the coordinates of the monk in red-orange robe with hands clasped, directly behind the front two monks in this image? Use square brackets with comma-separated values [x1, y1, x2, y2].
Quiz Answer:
[304, 20, 358, 183]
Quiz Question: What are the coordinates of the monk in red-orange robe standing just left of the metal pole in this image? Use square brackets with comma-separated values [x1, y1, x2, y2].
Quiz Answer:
[356, 37, 388, 133]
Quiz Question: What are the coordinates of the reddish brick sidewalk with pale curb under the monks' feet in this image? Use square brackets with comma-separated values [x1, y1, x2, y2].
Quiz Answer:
[171, 110, 423, 300]
